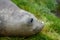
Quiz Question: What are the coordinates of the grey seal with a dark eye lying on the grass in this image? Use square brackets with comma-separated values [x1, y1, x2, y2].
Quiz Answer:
[0, 0, 44, 36]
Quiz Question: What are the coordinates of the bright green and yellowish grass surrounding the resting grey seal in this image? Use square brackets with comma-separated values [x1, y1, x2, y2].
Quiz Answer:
[0, 0, 60, 40]
